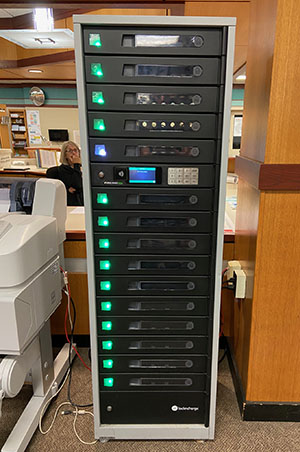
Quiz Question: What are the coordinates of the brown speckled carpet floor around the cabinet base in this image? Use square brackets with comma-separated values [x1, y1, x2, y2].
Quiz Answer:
[0, 350, 300, 452]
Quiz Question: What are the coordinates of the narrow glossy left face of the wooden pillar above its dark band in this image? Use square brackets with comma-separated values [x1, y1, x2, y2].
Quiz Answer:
[241, 0, 277, 162]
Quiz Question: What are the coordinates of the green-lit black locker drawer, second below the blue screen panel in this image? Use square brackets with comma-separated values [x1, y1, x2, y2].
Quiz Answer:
[93, 210, 213, 234]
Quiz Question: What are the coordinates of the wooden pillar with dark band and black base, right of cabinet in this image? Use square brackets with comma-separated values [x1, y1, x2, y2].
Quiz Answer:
[231, 0, 300, 421]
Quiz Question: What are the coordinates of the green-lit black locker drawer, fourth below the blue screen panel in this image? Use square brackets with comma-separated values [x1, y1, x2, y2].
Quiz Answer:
[95, 255, 211, 277]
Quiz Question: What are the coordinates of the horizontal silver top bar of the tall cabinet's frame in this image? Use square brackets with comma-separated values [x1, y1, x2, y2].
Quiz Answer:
[73, 14, 236, 26]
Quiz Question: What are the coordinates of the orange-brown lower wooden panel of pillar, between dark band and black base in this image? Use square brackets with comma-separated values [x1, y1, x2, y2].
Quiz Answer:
[246, 192, 300, 402]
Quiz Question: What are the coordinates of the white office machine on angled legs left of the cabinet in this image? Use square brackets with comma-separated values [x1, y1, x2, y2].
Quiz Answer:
[0, 179, 68, 452]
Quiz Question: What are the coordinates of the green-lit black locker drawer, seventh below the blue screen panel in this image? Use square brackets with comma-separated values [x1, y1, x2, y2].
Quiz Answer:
[97, 317, 208, 336]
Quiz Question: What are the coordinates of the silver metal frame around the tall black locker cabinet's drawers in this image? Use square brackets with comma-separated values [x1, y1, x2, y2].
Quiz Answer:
[73, 15, 236, 440]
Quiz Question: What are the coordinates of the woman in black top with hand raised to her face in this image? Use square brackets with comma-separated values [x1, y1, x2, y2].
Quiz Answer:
[46, 141, 83, 206]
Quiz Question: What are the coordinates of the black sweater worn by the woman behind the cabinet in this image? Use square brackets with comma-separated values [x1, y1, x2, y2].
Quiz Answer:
[46, 163, 83, 206]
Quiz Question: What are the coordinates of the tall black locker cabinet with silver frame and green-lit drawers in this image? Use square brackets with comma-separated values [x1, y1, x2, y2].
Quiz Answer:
[74, 16, 235, 440]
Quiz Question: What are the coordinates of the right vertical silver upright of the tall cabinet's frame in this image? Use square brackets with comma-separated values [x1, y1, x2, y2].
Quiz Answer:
[209, 23, 235, 439]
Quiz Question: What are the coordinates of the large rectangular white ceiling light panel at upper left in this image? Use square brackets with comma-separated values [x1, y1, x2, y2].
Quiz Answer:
[0, 28, 74, 49]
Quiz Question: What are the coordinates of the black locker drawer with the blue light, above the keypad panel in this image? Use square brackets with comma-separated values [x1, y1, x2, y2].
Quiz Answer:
[89, 137, 221, 165]
